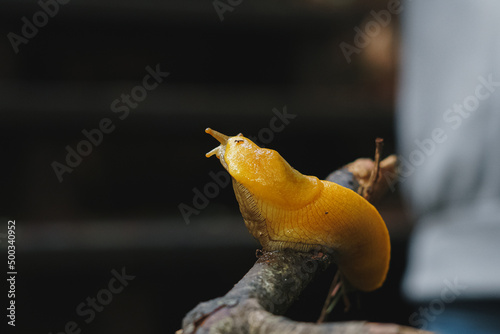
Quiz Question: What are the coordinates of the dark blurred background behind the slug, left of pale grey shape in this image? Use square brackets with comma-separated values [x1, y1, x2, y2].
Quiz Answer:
[0, 0, 412, 334]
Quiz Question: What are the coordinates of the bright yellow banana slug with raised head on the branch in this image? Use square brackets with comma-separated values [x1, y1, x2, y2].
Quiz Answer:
[205, 128, 390, 291]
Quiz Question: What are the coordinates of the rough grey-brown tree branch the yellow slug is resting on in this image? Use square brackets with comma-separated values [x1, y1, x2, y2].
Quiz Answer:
[177, 142, 428, 334]
